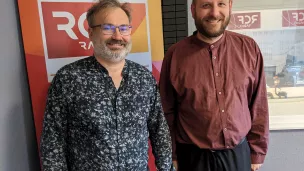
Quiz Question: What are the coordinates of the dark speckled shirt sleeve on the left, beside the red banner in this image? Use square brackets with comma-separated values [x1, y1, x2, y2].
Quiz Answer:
[40, 71, 68, 171]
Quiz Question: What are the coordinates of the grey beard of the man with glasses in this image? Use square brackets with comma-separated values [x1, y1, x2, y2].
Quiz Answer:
[93, 38, 132, 63]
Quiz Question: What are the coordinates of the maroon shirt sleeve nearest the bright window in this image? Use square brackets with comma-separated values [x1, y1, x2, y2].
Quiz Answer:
[247, 44, 269, 164]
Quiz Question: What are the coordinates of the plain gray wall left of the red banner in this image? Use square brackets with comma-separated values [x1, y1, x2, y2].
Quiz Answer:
[0, 0, 39, 171]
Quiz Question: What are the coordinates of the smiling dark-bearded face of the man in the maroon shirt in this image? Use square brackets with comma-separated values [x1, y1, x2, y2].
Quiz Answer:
[191, 0, 232, 38]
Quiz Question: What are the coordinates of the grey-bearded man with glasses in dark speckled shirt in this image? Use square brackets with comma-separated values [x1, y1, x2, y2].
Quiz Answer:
[41, 0, 173, 171]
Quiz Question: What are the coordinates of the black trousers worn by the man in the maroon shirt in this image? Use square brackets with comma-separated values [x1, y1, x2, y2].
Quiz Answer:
[176, 139, 251, 171]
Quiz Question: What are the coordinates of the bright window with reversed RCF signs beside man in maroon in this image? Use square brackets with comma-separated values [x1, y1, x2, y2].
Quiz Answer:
[228, 9, 304, 130]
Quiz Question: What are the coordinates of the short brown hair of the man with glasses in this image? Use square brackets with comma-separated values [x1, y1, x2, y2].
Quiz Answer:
[87, 0, 132, 27]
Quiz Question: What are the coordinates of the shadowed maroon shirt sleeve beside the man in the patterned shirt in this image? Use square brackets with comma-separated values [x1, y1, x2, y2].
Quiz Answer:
[159, 47, 177, 161]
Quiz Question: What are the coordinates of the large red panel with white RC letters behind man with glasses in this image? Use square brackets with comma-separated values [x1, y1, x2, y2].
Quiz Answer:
[41, 2, 93, 58]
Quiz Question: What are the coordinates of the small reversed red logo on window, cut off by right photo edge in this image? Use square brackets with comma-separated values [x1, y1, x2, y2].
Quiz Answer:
[282, 10, 304, 27]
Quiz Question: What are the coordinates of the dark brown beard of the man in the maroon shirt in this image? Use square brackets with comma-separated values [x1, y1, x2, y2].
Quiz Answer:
[194, 13, 230, 38]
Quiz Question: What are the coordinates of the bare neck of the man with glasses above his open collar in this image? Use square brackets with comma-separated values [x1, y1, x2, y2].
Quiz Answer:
[96, 57, 126, 76]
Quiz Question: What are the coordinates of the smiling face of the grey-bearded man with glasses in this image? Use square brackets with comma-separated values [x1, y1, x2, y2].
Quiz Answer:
[89, 8, 132, 63]
